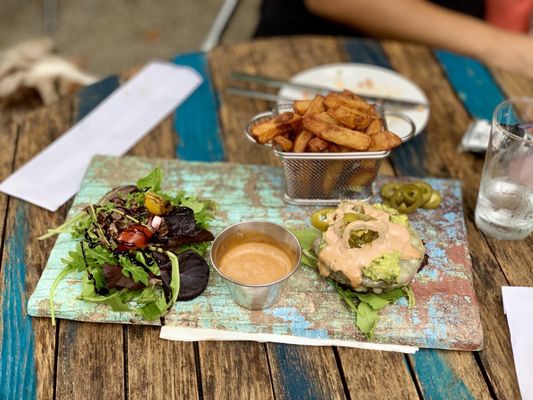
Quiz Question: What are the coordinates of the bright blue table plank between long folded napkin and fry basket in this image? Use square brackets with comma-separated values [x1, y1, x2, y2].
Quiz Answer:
[173, 52, 225, 161]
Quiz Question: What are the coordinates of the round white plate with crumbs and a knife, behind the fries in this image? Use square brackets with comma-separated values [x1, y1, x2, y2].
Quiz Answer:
[278, 63, 429, 137]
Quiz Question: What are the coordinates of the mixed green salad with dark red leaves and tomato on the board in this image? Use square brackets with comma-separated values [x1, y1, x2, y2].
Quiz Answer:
[39, 167, 215, 324]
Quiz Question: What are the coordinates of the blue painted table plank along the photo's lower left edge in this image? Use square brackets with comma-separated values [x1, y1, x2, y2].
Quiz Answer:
[0, 201, 37, 400]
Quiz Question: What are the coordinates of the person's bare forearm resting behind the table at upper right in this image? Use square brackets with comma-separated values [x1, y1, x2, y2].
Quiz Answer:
[304, 0, 533, 77]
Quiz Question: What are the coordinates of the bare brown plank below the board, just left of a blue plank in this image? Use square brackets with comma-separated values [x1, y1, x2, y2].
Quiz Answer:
[338, 347, 419, 400]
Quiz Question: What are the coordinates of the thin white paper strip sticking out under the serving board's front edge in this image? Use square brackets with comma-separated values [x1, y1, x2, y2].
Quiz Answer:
[159, 325, 418, 354]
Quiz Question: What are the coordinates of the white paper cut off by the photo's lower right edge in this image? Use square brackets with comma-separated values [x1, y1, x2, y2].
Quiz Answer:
[502, 286, 533, 400]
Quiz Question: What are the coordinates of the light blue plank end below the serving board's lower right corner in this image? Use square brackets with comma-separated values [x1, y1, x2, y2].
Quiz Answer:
[412, 349, 475, 400]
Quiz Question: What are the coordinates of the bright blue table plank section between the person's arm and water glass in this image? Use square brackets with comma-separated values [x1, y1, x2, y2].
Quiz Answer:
[435, 50, 505, 120]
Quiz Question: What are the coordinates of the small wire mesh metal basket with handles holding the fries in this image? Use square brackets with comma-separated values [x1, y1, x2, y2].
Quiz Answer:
[245, 105, 414, 205]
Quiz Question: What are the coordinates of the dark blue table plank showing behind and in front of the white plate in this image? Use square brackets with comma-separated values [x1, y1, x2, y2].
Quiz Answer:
[344, 38, 427, 176]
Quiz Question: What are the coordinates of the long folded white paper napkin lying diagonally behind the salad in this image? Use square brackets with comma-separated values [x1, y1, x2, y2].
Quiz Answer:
[0, 62, 202, 211]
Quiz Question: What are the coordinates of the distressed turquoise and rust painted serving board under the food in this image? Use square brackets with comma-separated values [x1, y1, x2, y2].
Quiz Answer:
[28, 156, 483, 350]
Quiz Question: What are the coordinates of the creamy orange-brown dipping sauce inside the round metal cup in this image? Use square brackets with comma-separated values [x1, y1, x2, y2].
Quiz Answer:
[217, 232, 296, 285]
